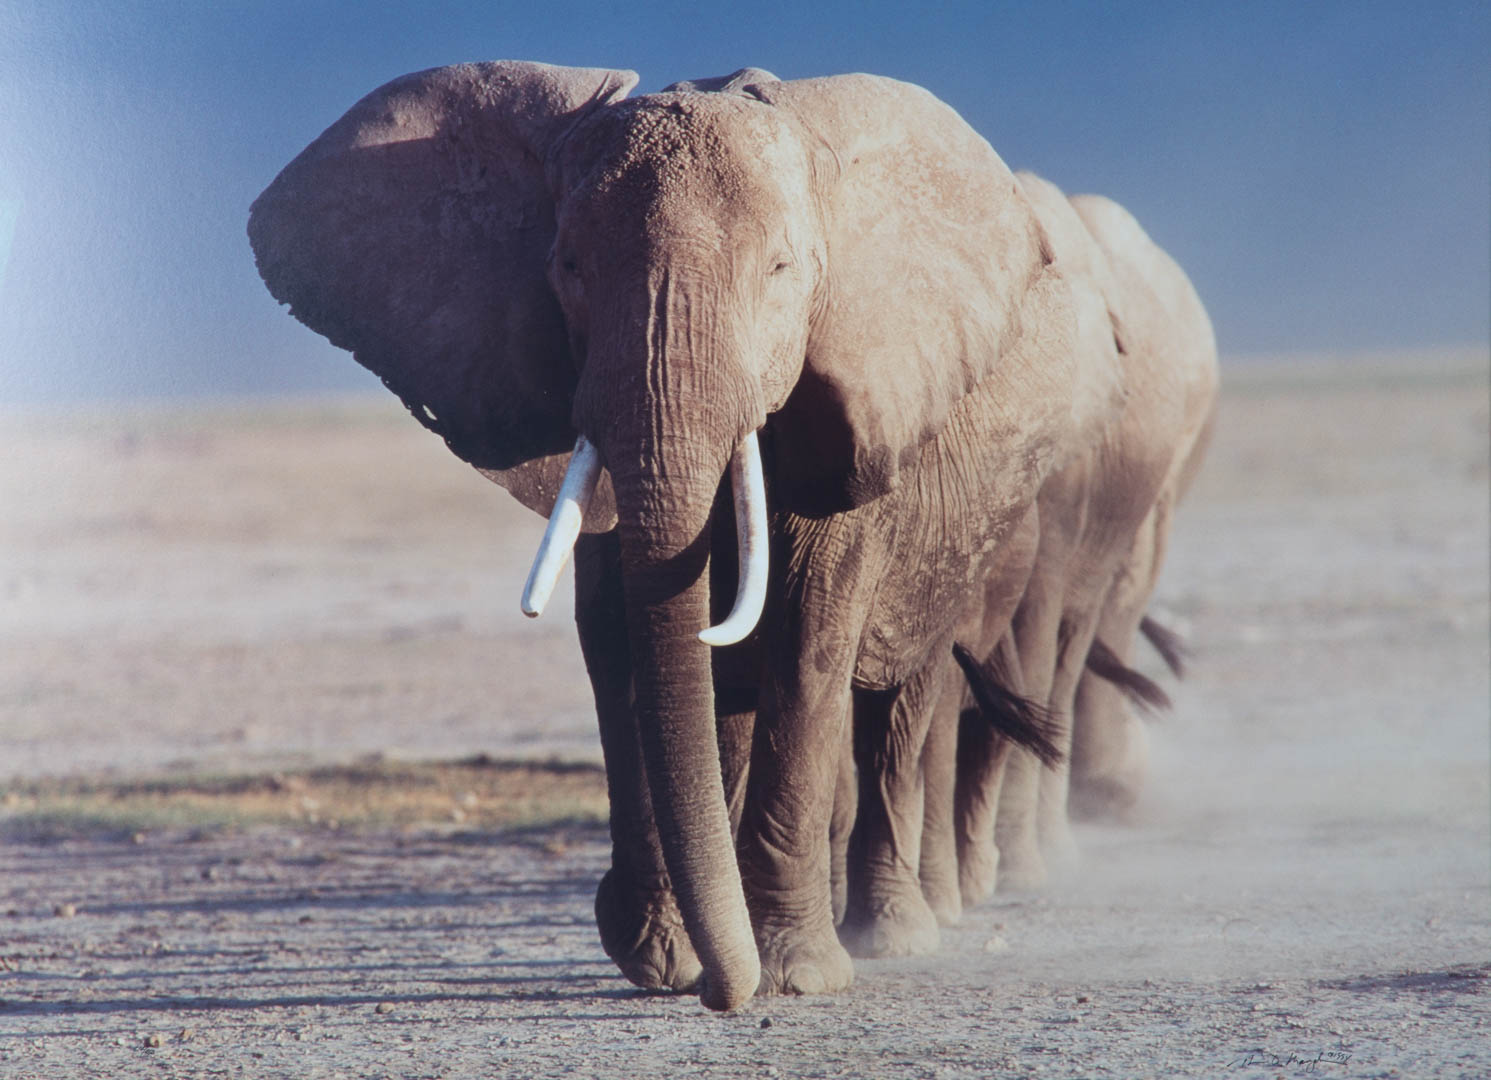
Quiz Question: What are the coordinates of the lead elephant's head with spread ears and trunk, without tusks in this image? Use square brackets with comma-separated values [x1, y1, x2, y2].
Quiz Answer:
[249, 61, 1060, 1007]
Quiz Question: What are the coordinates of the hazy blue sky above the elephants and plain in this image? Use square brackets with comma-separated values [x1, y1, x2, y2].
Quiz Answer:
[0, 0, 1491, 403]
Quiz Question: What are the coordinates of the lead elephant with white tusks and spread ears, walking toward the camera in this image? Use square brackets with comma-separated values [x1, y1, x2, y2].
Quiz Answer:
[249, 61, 1127, 1010]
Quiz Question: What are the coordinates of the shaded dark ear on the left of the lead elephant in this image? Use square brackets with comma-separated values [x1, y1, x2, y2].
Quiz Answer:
[249, 61, 637, 516]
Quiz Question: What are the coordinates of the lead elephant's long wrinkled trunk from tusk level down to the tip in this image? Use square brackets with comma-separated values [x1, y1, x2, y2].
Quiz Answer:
[610, 445, 760, 1008]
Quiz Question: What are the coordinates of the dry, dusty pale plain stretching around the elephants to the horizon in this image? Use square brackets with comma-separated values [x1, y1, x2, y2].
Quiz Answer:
[0, 352, 1491, 1077]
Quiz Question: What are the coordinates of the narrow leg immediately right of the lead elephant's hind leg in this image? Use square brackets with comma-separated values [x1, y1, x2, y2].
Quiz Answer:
[920, 671, 966, 926]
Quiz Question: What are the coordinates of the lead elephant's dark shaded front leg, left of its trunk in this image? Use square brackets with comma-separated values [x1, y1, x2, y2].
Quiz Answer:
[574, 533, 702, 990]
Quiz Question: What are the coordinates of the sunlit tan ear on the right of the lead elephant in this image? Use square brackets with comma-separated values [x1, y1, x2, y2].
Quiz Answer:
[746, 75, 1065, 515]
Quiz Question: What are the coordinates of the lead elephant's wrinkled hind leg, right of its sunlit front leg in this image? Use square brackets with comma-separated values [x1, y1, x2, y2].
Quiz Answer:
[839, 650, 951, 956]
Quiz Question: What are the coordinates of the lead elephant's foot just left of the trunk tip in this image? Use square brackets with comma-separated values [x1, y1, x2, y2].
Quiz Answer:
[595, 870, 704, 992]
